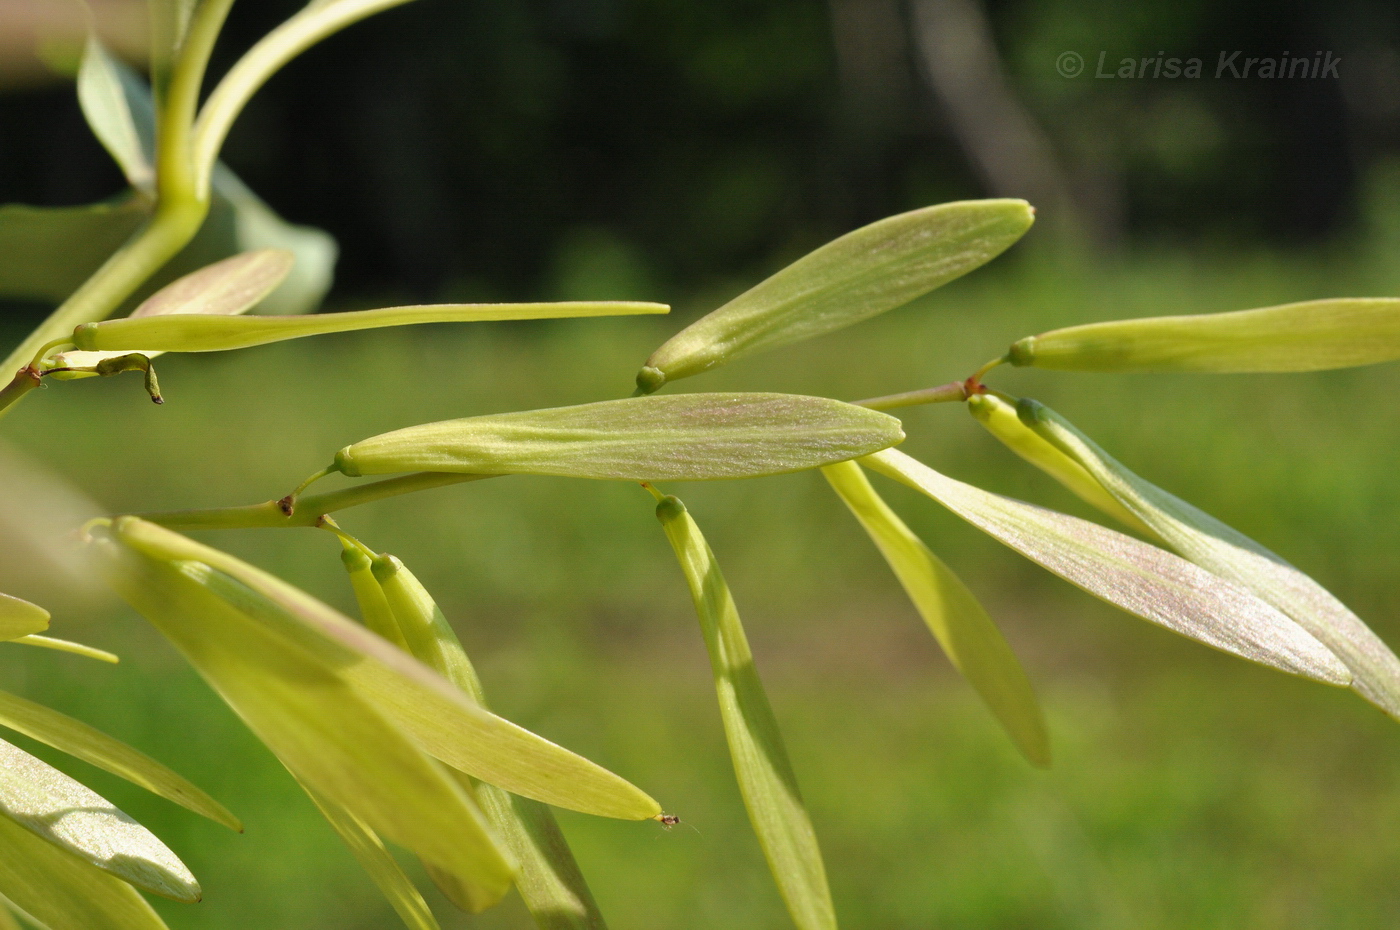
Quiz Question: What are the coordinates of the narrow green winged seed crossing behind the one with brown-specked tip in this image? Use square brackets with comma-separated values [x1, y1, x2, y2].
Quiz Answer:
[361, 555, 606, 930]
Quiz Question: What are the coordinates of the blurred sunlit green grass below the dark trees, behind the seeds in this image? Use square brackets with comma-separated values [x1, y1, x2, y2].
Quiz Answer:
[0, 238, 1400, 930]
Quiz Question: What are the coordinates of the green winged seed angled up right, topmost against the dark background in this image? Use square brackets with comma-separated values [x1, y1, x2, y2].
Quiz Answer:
[637, 200, 1035, 394]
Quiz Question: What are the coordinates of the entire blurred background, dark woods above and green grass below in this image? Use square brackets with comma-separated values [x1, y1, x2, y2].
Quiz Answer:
[0, 0, 1400, 930]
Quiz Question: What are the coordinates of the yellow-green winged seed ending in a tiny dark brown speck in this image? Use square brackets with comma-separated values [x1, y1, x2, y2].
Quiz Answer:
[112, 517, 661, 817]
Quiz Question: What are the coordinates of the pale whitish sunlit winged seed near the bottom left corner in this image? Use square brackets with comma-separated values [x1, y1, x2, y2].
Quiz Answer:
[0, 740, 199, 901]
